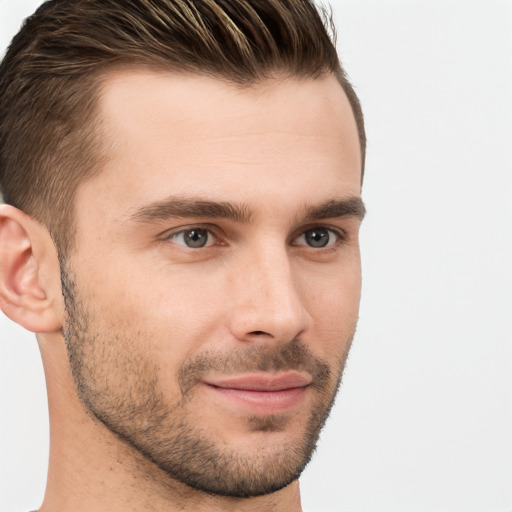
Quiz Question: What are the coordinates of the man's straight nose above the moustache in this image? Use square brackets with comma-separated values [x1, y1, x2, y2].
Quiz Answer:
[230, 244, 311, 343]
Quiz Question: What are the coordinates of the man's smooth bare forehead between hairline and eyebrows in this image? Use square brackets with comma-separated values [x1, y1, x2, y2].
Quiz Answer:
[78, 70, 361, 224]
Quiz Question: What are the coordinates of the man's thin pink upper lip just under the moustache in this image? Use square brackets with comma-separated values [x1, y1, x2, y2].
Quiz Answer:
[204, 372, 311, 391]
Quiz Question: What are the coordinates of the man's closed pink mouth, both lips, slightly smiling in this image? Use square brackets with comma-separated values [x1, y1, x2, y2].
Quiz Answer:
[203, 372, 311, 415]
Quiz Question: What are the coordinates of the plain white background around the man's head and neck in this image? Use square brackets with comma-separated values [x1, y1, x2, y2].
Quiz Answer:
[0, 0, 512, 512]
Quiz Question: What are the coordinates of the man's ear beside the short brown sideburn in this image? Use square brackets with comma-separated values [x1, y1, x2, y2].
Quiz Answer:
[0, 205, 64, 333]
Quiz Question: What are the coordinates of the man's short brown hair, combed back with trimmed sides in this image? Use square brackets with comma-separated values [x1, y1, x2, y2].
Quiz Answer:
[0, 0, 366, 254]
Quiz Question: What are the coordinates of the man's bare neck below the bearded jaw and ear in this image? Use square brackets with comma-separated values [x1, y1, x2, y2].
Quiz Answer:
[39, 334, 301, 512]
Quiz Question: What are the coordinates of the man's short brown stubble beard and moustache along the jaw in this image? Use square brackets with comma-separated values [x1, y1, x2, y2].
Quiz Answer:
[61, 265, 352, 498]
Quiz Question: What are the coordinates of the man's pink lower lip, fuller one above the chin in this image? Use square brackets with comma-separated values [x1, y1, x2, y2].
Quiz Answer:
[206, 384, 307, 414]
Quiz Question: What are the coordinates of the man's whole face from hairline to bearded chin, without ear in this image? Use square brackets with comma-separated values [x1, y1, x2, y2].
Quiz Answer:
[63, 71, 362, 496]
